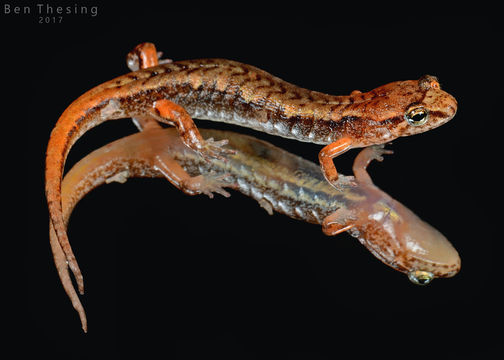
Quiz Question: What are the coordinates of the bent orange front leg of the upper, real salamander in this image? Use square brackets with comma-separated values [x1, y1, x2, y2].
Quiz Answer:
[319, 137, 356, 190]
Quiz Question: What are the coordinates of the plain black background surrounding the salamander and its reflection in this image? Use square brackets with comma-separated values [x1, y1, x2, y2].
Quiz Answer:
[0, 2, 502, 359]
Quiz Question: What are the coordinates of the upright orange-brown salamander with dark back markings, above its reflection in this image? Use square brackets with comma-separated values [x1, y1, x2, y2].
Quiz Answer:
[45, 44, 457, 292]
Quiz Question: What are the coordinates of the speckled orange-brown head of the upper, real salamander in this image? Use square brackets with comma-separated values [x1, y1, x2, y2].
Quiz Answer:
[350, 75, 457, 142]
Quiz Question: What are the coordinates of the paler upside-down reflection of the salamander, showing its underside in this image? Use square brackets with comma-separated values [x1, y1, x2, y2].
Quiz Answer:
[50, 129, 460, 331]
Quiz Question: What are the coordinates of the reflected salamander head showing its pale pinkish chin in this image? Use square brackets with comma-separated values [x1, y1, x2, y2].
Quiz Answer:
[350, 194, 460, 285]
